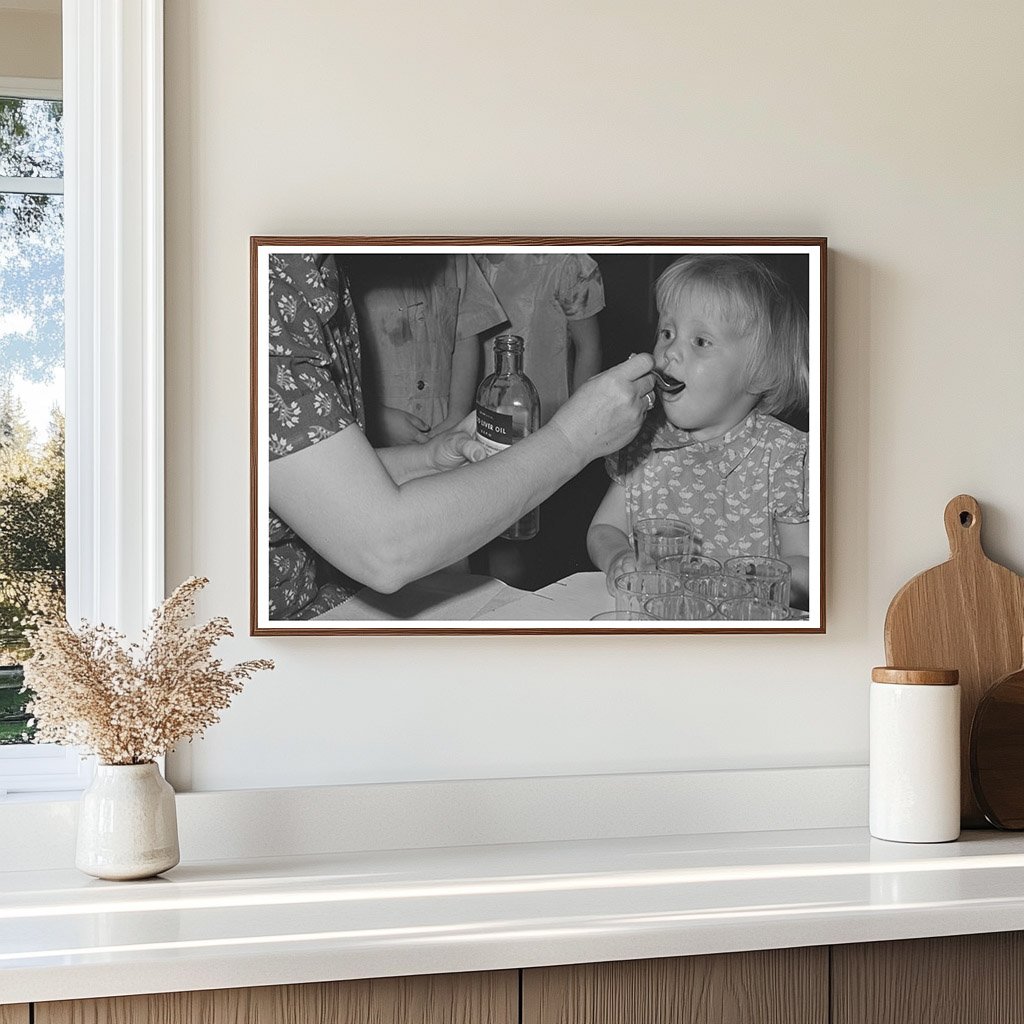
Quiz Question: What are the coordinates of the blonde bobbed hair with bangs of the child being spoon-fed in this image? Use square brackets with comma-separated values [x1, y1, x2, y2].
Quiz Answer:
[654, 253, 808, 416]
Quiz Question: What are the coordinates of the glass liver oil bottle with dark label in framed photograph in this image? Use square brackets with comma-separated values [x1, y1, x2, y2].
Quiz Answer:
[476, 334, 541, 541]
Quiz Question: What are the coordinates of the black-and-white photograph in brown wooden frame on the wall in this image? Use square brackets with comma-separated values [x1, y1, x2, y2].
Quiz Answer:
[250, 237, 826, 635]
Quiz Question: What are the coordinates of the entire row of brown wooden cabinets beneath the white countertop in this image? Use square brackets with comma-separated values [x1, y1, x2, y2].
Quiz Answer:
[16, 932, 1024, 1024]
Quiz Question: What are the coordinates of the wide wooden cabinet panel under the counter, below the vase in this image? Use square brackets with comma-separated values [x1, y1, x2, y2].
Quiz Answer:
[35, 971, 519, 1024]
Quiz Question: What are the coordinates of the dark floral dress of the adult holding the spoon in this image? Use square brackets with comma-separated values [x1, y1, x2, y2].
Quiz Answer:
[269, 253, 365, 620]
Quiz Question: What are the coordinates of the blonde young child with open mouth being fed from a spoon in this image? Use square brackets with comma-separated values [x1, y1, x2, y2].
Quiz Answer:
[587, 254, 809, 608]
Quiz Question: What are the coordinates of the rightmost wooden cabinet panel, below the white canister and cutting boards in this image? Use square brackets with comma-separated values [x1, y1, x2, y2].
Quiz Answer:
[831, 932, 1024, 1024]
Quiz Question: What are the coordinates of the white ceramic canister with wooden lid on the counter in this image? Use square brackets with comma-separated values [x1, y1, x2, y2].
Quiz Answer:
[869, 669, 961, 843]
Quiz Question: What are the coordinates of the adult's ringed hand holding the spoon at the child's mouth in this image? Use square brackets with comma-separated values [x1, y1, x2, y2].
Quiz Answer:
[551, 352, 654, 462]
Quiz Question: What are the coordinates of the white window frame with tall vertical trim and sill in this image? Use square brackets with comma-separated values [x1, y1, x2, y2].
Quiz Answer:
[0, 0, 164, 799]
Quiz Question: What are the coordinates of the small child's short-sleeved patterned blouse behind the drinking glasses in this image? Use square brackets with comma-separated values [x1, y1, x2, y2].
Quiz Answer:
[606, 410, 810, 561]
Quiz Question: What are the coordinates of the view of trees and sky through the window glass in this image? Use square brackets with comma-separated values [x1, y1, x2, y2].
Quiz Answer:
[0, 95, 65, 744]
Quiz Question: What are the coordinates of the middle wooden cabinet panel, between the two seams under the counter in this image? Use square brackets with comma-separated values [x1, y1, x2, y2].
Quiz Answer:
[522, 947, 827, 1024]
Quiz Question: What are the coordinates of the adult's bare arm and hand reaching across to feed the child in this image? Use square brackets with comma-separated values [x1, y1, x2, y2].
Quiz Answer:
[269, 354, 652, 593]
